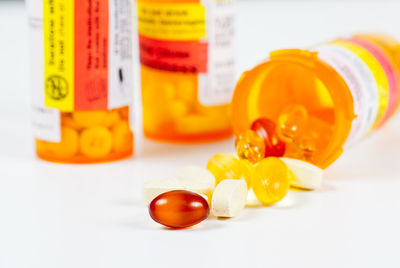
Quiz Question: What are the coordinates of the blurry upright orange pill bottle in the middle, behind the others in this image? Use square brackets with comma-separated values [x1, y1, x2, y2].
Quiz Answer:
[137, 0, 236, 142]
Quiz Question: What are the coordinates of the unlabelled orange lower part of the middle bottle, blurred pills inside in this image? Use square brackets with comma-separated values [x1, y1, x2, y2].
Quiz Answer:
[141, 66, 231, 140]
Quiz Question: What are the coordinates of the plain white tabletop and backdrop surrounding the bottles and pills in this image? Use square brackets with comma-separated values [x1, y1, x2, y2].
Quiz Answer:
[0, 1, 400, 268]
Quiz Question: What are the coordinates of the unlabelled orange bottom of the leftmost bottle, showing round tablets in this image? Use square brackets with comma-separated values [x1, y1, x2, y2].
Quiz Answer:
[36, 107, 133, 161]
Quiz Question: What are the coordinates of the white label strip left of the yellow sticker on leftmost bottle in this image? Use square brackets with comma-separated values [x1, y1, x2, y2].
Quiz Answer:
[26, 0, 61, 142]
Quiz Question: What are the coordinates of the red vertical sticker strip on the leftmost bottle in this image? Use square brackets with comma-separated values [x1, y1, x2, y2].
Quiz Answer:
[74, 0, 109, 110]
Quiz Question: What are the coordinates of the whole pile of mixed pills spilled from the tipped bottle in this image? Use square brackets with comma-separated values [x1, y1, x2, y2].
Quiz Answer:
[142, 114, 323, 228]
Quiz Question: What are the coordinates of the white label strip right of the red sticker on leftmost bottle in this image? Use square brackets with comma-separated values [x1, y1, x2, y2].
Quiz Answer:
[108, 0, 133, 109]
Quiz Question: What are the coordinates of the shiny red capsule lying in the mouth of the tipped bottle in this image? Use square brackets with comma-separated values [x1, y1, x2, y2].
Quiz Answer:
[251, 118, 286, 157]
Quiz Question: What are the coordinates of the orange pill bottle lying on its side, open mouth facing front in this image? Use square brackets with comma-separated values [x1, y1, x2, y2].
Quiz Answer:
[232, 34, 400, 168]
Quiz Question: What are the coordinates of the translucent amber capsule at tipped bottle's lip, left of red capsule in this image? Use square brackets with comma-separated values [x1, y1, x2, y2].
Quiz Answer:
[236, 130, 265, 164]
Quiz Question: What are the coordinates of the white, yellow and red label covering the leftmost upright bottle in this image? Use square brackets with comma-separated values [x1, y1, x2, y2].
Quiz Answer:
[26, 0, 133, 142]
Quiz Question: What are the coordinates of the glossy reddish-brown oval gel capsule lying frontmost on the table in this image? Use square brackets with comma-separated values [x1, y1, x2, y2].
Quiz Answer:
[149, 190, 210, 229]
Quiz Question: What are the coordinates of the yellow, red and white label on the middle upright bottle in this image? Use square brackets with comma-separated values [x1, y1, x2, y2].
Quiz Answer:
[138, 0, 235, 106]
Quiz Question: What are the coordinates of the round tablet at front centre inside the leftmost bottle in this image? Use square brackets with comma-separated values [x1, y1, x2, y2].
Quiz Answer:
[80, 126, 112, 158]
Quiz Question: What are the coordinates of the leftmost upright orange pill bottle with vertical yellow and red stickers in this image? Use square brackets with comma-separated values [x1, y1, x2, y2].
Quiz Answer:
[27, 0, 133, 163]
